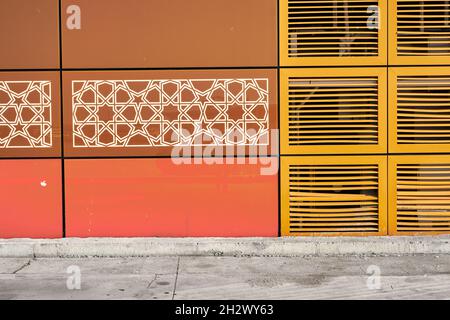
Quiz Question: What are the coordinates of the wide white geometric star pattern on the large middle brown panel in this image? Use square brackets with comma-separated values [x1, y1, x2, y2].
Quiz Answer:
[72, 79, 269, 148]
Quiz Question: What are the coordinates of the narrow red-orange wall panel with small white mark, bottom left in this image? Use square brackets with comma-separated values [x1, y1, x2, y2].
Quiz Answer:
[0, 159, 63, 238]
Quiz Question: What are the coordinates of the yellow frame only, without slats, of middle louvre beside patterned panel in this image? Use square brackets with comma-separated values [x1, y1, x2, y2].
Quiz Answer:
[280, 68, 388, 154]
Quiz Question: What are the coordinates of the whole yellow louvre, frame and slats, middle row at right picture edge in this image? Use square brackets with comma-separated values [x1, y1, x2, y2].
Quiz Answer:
[389, 67, 450, 153]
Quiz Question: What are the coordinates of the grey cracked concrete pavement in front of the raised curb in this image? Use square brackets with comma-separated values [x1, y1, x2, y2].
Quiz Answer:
[0, 255, 450, 299]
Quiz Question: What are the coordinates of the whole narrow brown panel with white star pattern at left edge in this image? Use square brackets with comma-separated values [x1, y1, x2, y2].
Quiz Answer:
[0, 72, 61, 157]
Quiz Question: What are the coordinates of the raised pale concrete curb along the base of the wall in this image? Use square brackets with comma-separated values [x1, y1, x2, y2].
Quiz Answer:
[0, 235, 450, 258]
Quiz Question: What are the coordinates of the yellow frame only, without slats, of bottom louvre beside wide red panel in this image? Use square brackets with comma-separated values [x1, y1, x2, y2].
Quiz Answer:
[280, 156, 388, 236]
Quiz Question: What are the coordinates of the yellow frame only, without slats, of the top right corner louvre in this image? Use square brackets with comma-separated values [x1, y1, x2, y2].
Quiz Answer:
[388, 0, 450, 65]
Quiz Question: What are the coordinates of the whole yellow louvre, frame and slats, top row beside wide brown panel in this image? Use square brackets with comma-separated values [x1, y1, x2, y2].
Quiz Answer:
[280, 0, 387, 66]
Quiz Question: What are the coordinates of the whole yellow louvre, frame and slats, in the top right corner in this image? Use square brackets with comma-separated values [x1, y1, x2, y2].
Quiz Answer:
[389, 0, 450, 64]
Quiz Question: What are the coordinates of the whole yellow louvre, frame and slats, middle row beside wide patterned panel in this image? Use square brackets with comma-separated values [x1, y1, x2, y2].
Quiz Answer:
[281, 68, 387, 154]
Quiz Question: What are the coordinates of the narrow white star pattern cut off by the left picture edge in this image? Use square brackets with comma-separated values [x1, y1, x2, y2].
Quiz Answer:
[0, 81, 52, 148]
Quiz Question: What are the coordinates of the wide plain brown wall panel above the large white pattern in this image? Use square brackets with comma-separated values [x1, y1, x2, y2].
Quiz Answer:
[61, 0, 278, 68]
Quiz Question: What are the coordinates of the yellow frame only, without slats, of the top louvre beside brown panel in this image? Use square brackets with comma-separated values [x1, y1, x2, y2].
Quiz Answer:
[279, 0, 392, 66]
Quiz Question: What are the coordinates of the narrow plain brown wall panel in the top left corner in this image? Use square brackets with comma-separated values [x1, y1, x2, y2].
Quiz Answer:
[0, 0, 59, 69]
